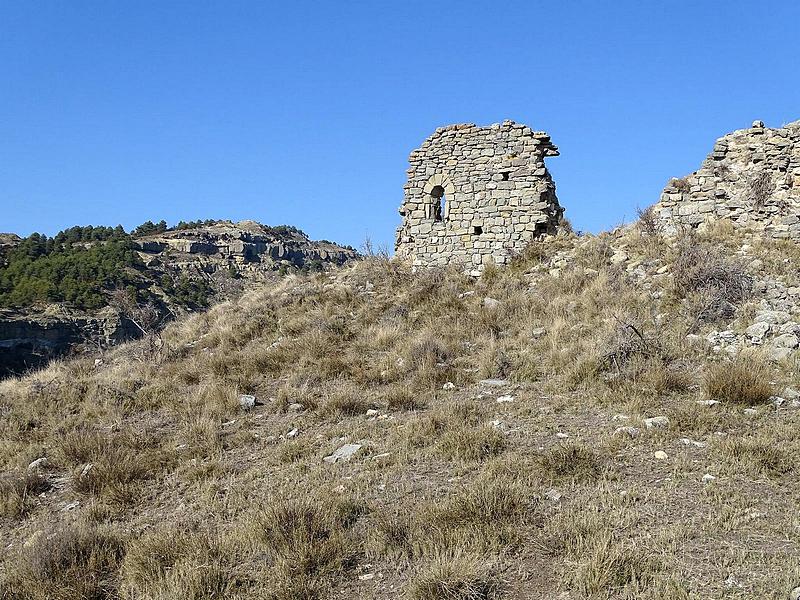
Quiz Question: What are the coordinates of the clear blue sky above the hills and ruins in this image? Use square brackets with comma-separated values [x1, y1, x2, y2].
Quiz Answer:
[0, 0, 800, 246]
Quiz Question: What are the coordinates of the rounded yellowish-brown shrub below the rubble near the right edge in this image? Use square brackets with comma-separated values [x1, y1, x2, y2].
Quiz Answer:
[704, 355, 774, 406]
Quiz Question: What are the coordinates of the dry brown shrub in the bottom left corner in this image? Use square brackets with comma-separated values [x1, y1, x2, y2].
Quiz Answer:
[5, 525, 125, 600]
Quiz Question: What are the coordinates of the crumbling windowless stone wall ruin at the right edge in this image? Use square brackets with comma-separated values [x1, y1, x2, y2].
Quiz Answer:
[654, 121, 800, 240]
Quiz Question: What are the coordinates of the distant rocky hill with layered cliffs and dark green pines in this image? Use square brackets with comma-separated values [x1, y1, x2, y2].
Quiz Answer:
[0, 221, 357, 376]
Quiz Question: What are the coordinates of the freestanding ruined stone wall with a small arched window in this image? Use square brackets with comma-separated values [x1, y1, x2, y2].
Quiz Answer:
[395, 121, 563, 272]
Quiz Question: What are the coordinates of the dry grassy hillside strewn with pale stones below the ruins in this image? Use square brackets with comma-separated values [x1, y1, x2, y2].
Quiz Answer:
[0, 219, 800, 600]
